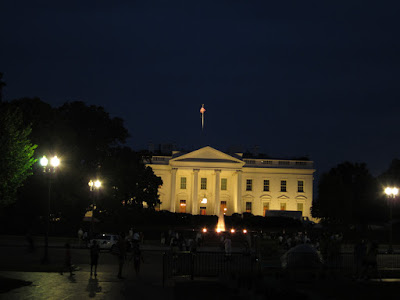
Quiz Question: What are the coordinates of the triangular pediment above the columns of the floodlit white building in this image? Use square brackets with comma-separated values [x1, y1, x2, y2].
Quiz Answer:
[170, 146, 244, 167]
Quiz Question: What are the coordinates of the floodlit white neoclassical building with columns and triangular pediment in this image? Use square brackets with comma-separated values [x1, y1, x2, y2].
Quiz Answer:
[147, 146, 315, 219]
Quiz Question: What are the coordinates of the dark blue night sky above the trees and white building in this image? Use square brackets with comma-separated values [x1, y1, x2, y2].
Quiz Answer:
[0, 0, 400, 175]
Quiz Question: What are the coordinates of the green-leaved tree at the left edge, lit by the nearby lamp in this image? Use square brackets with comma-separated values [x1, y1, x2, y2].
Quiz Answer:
[0, 103, 37, 207]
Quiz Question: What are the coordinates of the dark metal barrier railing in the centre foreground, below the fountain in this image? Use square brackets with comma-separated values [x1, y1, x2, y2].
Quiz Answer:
[163, 251, 258, 283]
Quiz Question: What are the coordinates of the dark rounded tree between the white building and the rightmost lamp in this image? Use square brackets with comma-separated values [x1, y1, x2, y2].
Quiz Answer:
[312, 162, 380, 224]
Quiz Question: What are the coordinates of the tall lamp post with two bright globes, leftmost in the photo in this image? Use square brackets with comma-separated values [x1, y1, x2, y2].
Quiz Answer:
[40, 156, 60, 263]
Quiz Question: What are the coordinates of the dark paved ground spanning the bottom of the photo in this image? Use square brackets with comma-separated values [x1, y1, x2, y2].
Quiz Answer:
[0, 238, 400, 300]
